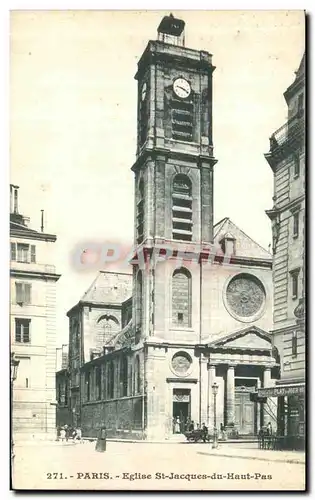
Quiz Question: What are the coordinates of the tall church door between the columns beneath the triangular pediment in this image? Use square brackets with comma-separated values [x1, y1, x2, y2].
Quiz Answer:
[235, 391, 256, 435]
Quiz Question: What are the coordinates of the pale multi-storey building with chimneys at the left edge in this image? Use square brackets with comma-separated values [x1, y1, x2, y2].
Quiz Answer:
[10, 185, 60, 440]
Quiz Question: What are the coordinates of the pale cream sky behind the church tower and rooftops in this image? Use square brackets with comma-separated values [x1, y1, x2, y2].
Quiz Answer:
[10, 10, 305, 344]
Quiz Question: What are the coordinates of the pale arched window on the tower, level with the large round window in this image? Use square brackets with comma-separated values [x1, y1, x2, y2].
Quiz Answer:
[172, 267, 191, 328]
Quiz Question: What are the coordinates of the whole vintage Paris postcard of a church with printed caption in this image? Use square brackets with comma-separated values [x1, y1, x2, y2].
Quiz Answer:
[10, 10, 306, 491]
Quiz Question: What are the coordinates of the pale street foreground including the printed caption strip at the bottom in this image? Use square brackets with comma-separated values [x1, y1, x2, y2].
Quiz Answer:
[13, 442, 305, 490]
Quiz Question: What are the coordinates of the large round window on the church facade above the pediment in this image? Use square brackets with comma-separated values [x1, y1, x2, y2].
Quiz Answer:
[226, 274, 266, 318]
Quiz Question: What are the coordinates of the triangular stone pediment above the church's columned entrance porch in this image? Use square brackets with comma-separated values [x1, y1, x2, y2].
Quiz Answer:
[208, 327, 271, 350]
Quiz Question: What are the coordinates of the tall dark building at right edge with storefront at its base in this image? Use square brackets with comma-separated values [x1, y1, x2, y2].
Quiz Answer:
[259, 55, 305, 447]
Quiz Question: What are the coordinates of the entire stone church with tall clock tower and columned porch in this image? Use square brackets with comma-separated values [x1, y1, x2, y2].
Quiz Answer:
[57, 15, 279, 440]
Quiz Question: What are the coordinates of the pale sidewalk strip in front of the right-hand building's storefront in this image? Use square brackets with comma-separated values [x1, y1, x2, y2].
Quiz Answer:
[197, 445, 305, 464]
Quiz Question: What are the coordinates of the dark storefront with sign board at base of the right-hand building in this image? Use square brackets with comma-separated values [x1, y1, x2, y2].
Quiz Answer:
[257, 382, 305, 450]
